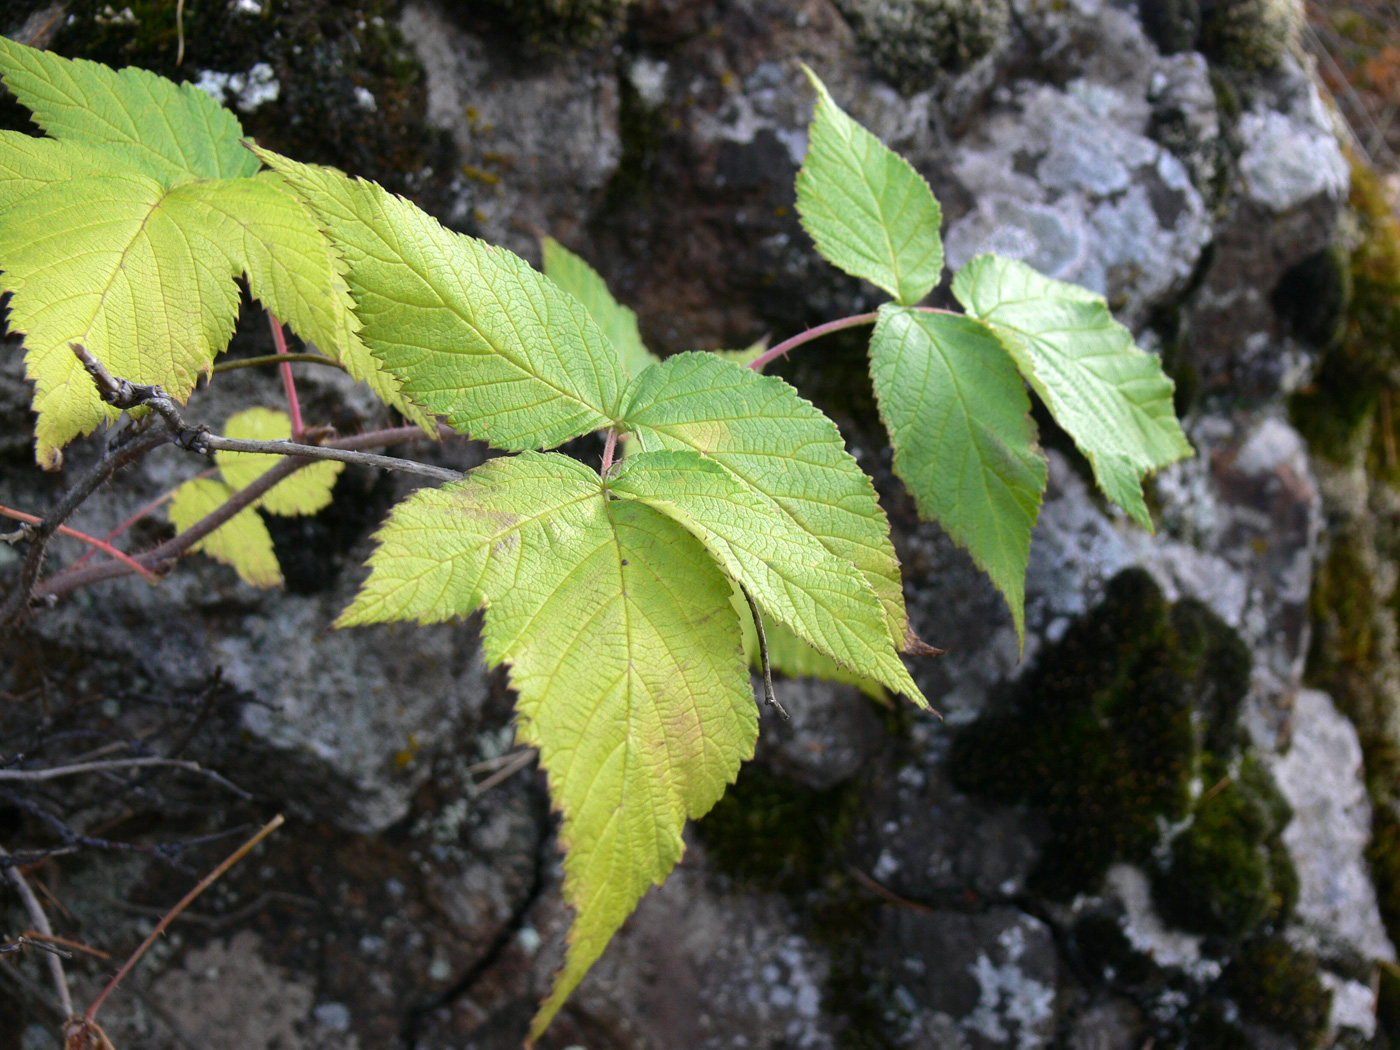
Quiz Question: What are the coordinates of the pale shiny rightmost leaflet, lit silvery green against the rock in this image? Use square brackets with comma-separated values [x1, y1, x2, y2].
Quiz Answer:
[953, 255, 1193, 529]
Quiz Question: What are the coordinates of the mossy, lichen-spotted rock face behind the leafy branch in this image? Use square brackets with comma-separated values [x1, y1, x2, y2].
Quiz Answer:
[0, 0, 1400, 1050]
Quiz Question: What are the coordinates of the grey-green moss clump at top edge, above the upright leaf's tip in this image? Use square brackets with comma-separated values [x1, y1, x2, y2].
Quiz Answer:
[836, 0, 1009, 94]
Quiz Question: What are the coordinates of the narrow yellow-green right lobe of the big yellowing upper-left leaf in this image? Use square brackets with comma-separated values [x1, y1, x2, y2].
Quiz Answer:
[191, 171, 437, 437]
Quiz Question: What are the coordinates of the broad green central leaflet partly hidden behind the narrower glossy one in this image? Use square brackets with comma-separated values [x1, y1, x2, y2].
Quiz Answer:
[624, 353, 917, 674]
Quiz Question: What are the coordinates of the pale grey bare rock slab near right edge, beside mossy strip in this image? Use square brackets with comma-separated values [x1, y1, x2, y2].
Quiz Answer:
[1273, 689, 1396, 962]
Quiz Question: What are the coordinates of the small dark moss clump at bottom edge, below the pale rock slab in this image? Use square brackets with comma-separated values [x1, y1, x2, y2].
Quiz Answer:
[1222, 935, 1331, 1050]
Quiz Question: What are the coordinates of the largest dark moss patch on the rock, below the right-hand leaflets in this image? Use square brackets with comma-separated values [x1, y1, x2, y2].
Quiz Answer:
[951, 568, 1249, 899]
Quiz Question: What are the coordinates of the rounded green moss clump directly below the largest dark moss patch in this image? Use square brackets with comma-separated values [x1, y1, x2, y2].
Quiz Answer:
[1152, 757, 1298, 941]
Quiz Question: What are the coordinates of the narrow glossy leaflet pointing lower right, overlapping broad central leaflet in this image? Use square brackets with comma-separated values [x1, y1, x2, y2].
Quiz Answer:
[608, 449, 918, 696]
